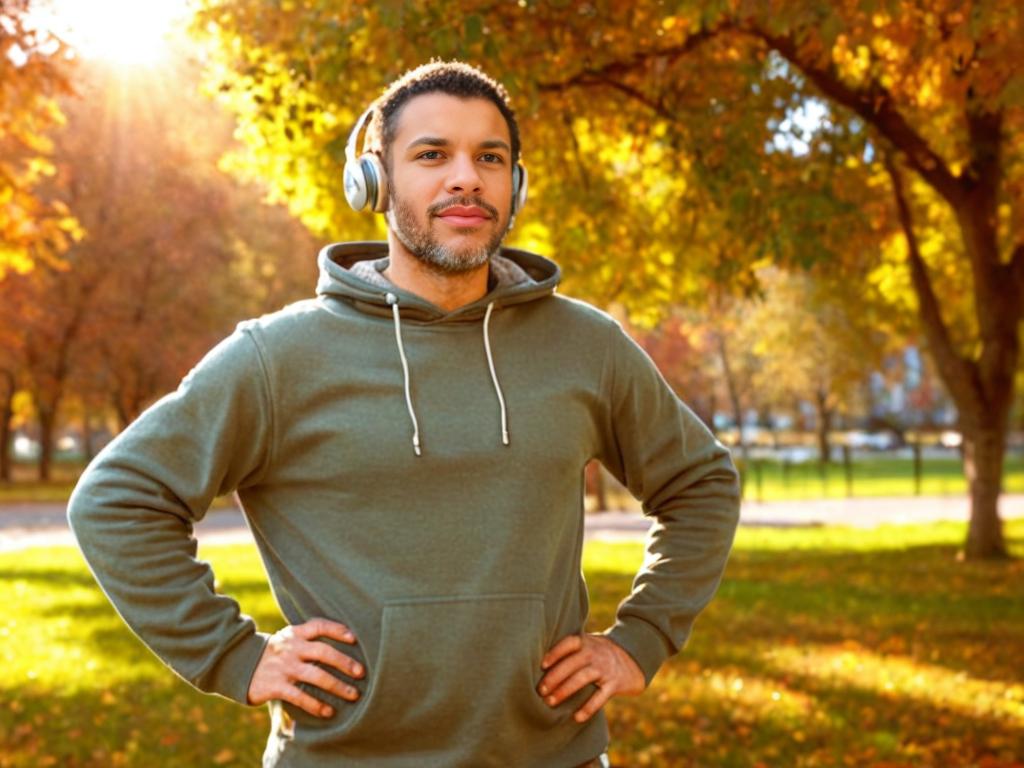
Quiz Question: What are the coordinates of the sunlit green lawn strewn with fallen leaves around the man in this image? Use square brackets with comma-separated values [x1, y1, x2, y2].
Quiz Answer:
[0, 520, 1024, 768]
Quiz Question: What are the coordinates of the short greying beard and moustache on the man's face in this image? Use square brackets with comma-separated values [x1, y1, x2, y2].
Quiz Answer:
[386, 188, 508, 274]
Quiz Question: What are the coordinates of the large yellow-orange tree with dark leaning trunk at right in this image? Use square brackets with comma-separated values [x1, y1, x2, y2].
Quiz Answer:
[188, 0, 1024, 557]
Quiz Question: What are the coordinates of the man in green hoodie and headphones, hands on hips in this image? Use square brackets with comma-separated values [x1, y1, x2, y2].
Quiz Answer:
[69, 62, 738, 768]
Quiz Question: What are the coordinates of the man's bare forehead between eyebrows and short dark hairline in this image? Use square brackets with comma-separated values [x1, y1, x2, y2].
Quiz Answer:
[394, 93, 511, 151]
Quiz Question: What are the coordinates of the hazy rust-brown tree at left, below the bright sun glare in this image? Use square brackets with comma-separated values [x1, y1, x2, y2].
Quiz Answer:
[0, 58, 316, 479]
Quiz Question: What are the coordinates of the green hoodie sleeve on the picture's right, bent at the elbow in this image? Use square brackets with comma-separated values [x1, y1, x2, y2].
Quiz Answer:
[597, 323, 739, 684]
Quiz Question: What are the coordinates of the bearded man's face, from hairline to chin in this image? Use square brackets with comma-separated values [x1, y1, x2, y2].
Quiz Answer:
[387, 93, 512, 273]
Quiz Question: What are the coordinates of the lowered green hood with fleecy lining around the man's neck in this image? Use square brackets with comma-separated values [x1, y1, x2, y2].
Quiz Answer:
[316, 241, 561, 324]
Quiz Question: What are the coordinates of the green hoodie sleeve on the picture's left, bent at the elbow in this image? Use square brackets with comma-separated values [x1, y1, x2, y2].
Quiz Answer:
[68, 324, 272, 703]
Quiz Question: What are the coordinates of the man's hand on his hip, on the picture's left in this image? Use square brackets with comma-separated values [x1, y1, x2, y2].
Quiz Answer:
[249, 618, 365, 718]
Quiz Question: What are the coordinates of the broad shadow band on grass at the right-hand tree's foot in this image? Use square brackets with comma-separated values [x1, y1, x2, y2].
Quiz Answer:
[588, 546, 1024, 683]
